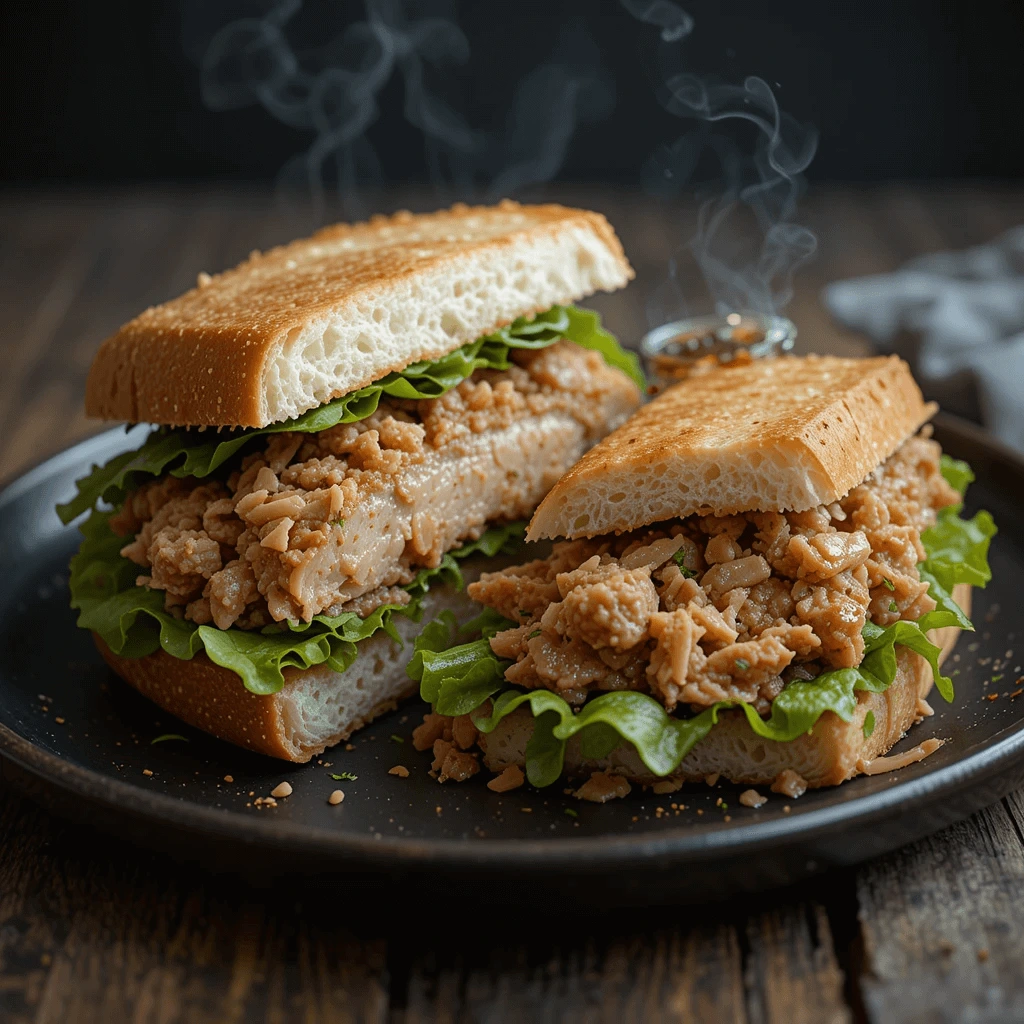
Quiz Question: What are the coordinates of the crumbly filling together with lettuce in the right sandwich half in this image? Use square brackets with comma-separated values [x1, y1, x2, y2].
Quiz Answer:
[409, 436, 995, 786]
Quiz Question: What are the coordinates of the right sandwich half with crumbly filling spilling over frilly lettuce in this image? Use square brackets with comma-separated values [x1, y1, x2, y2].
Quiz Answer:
[410, 356, 995, 802]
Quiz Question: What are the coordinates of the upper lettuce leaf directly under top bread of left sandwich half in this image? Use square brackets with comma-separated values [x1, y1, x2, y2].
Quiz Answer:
[57, 306, 645, 523]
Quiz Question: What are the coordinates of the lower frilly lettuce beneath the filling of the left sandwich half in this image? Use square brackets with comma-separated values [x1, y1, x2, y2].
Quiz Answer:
[71, 511, 525, 693]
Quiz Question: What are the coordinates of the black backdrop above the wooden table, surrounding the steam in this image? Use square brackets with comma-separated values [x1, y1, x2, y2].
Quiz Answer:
[0, 0, 1024, 185]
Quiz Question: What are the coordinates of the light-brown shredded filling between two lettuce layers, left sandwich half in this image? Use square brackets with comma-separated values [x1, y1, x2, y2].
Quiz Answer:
[111, 342, 636, 629]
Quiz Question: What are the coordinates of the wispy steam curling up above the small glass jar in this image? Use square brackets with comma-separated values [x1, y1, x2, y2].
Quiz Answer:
[622, 0, 818, 323]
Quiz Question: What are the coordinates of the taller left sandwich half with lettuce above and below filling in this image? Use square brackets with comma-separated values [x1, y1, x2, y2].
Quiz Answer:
[57, 202, 643, 761]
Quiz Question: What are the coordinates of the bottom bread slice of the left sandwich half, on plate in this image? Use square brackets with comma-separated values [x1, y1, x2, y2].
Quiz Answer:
[93, 572, 480, 762]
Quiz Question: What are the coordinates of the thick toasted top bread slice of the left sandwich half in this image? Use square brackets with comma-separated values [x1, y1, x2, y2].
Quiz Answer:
[86, 201, 633, 427]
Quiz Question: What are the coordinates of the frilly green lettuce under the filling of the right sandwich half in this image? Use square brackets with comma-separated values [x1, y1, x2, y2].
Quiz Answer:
[409, 464, 995, 786]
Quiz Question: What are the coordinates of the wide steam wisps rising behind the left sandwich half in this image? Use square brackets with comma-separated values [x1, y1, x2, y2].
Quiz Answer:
[202, 0, 613, 219]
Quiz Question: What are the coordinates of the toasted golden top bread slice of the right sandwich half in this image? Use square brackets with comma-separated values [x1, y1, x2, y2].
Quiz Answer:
[527, 355, 936, 541]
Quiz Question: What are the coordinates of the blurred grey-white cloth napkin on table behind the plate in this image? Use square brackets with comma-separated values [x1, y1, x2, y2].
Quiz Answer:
[822, 226, 1024, 452]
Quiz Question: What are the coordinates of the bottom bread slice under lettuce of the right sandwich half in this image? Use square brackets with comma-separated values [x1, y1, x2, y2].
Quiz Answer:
[478, 585, 971, 788]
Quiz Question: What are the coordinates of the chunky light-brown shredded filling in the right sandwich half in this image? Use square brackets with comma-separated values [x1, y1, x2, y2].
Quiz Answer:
[469, 434, 958, 714]
